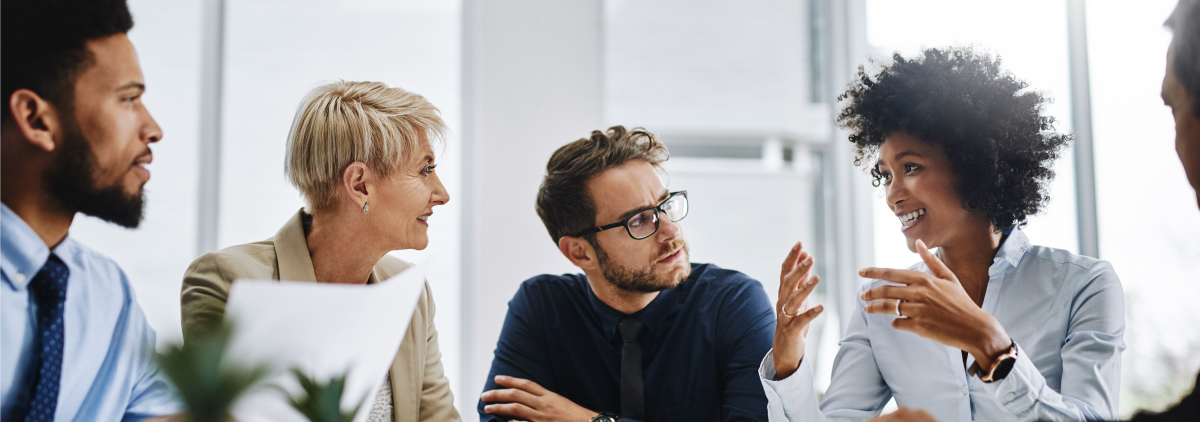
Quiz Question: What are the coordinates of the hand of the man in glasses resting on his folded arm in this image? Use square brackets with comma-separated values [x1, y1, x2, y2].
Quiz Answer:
[480, 375, 599, 422]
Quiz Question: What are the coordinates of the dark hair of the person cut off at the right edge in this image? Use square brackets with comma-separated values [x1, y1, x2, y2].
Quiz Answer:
[1164, 0, 1200, 119]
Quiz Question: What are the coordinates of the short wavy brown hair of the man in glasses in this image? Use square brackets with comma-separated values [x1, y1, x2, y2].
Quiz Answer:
[536, 126, 670, 245]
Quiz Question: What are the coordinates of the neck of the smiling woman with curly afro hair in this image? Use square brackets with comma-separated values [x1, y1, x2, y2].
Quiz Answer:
[937, 224, 1003, 306]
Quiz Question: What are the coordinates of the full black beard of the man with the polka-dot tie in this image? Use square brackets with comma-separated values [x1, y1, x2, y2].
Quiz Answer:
[42, 115, 145, 229]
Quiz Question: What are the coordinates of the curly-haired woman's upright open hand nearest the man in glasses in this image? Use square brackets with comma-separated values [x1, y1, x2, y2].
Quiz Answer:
[772, 242, 824, 380]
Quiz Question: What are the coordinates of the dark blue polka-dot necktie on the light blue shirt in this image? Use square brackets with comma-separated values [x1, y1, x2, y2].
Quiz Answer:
[25, 254, 71, 422]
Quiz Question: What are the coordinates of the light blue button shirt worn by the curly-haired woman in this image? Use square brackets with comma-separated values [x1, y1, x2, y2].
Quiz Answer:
[758, 229, 1124, 422]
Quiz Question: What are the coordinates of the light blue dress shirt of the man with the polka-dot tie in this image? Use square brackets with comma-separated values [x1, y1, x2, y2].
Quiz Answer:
[0, 205, 180, 421]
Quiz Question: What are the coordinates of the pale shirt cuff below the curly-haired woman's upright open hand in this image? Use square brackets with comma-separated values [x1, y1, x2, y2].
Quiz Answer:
[758, 349, 821, 421]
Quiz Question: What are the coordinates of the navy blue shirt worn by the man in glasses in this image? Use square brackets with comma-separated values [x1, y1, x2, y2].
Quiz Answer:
[478, 264, 775, 422]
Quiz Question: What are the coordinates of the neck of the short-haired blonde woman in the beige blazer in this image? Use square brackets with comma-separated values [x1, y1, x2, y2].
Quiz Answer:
[305, 209, 388, 284]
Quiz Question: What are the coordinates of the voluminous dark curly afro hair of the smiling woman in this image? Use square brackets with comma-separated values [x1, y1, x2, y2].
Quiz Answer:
[838, 47, 1072, 230]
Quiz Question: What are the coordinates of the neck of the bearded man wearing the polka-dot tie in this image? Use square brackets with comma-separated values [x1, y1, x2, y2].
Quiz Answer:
[0, 167, 76, 249]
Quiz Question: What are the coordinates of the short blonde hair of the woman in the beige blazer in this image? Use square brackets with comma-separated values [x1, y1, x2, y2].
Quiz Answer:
[283, 80, 446, 212]
